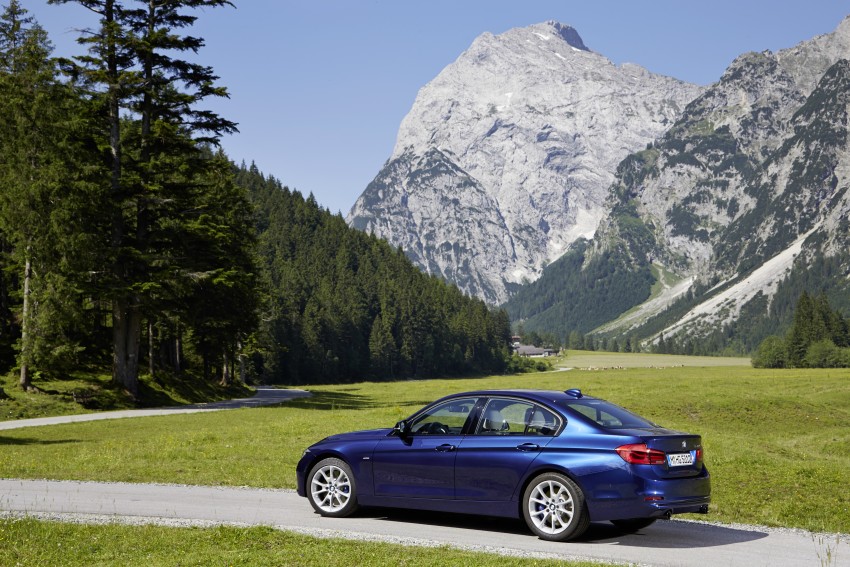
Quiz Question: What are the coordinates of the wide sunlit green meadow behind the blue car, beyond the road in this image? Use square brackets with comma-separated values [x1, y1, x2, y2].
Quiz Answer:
[0, 367, 850, 533]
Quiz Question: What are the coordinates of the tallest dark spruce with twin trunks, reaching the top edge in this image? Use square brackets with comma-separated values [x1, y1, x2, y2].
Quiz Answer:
[50, 0, 236, 395]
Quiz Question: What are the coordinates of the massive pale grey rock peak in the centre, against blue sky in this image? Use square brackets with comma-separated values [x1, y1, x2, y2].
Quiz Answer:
[348, 22, 704, 304]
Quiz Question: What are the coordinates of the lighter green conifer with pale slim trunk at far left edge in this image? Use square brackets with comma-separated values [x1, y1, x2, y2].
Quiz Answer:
[0, 0, 93, 389]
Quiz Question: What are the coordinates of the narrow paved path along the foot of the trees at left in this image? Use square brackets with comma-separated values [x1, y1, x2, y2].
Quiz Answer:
[0, 388, 310, 431]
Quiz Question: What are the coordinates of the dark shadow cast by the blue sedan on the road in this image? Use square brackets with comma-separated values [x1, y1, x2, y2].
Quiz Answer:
[359, 508, 768, 549]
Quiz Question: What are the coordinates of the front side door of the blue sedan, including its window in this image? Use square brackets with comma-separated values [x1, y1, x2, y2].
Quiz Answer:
[372, 397, 478, 499]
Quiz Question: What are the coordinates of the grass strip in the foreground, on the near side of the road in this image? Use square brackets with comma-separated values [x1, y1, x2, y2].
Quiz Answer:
[0, 519, 600, 567]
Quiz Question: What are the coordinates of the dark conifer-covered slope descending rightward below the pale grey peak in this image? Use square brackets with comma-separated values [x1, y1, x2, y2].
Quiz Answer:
[236, 165, 510, 384]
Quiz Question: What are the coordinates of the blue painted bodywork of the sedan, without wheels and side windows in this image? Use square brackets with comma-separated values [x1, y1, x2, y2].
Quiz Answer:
[296, 391, 711, 532]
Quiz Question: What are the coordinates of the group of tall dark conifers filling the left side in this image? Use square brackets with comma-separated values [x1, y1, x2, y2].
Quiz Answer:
[0, 0, 257, 397]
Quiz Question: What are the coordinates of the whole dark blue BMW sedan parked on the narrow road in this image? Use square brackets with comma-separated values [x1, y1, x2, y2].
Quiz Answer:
[296, 390, 711, 541]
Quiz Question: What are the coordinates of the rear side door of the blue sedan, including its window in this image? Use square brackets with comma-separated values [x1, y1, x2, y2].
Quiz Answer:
[455, 398, 560, 501]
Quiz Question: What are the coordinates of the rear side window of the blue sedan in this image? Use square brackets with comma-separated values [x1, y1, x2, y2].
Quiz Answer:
[476, 399, 559, 435]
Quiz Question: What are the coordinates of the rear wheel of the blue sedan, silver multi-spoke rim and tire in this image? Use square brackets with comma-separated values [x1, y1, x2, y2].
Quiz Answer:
[522, 473, 590, 541]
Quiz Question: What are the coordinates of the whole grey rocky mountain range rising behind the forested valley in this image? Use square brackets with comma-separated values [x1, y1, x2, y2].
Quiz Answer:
[348, 17, 850, 350]
